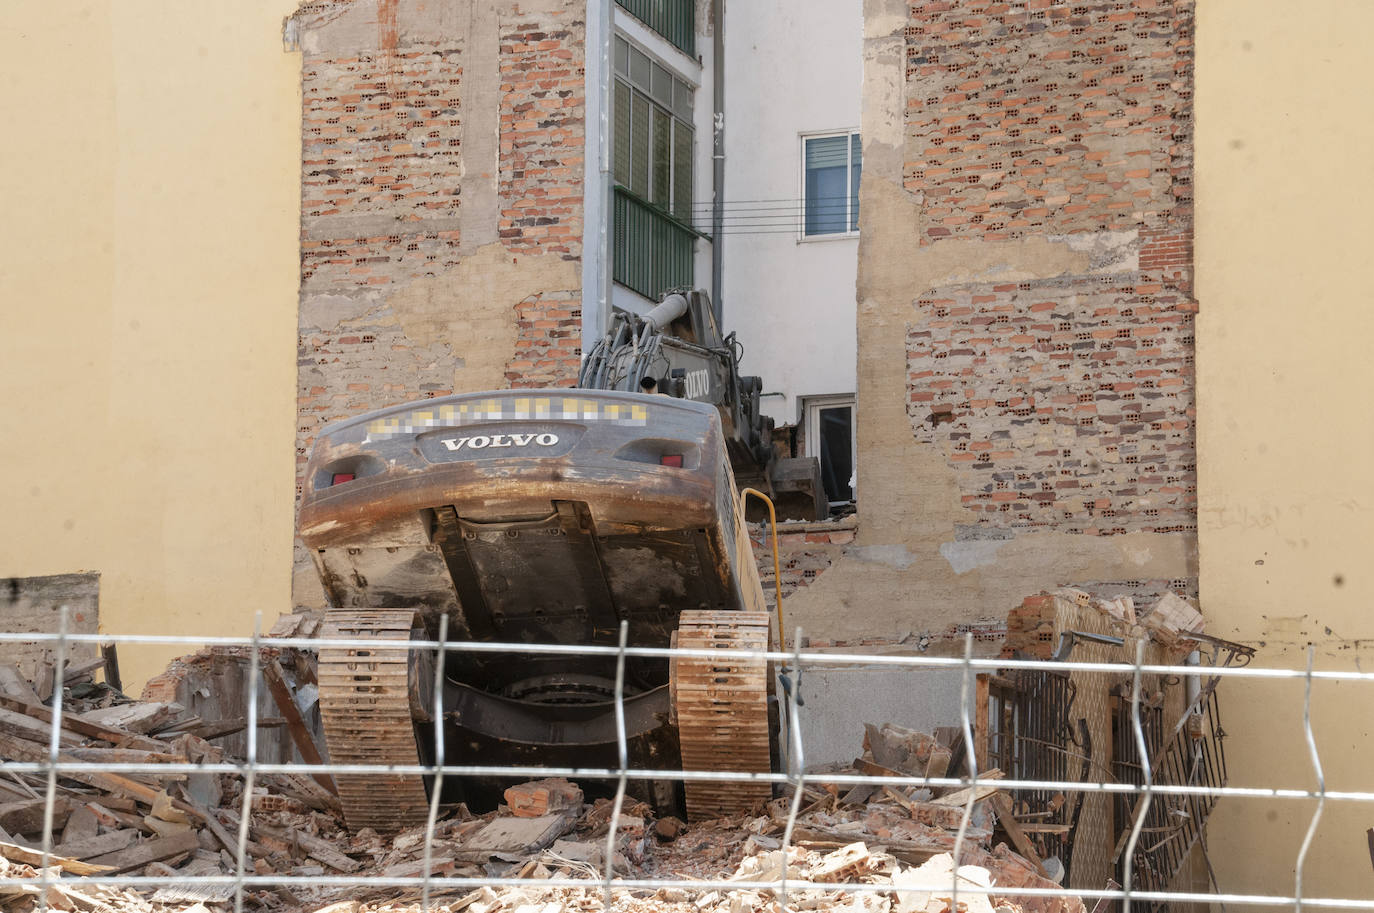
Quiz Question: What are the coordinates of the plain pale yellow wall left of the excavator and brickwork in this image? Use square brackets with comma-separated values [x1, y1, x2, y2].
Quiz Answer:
[0, 0, 301, 683]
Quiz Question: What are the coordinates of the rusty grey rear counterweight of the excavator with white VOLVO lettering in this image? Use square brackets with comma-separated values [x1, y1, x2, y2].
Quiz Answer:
[300, 391, 724, 547]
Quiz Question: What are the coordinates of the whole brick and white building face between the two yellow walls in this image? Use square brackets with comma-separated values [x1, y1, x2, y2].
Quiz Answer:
[278, 0, 1352, 896]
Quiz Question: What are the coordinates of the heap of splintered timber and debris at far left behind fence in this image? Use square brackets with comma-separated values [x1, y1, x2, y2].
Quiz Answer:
[0, 651, 340, 913]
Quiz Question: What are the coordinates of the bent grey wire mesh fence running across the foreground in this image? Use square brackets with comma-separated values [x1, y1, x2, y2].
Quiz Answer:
[0, 612, 1374, 913]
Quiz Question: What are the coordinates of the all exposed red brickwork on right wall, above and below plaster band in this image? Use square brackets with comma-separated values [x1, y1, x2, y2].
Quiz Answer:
[903, 0, 1197, 539]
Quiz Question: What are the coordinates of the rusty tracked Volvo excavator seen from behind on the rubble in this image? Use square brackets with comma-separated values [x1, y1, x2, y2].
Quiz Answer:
[298, 387, 778, 831]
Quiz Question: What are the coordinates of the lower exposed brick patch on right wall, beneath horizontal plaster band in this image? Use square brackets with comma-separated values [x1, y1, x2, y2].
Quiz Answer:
[907, 275, 1197, 535]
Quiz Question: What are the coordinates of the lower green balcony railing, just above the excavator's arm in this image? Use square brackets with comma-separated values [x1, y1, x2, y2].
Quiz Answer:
[611, 187, 698, 298]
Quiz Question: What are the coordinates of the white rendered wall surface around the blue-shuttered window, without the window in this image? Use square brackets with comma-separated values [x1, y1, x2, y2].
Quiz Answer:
[721, 0, 863, 424]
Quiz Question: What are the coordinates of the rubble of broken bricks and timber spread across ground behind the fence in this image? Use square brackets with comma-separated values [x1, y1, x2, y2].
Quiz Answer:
[0, 640, 1083, 913]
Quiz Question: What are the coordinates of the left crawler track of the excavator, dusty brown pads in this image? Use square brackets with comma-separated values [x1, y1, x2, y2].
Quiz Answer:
[319, 609, 429, 832]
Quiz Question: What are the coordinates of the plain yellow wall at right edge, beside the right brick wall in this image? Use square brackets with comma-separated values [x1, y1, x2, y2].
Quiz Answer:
[1195, 0, 1374, 899]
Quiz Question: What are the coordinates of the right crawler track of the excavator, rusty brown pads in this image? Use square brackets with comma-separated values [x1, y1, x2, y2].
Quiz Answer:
[672, 611, 772, 821]
